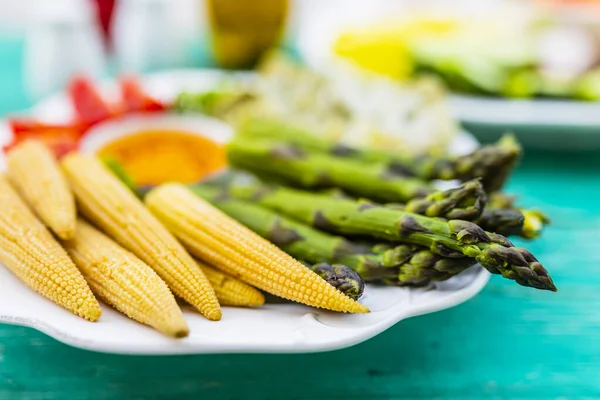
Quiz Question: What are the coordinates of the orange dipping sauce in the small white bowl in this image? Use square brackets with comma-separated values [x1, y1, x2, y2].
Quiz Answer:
[98, 130, 227, 185]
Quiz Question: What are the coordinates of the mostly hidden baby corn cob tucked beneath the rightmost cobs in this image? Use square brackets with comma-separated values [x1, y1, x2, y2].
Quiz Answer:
[198, 262, 265, 307]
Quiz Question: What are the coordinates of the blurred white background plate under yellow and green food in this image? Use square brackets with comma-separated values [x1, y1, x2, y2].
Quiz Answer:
[296, 0, 600, 151]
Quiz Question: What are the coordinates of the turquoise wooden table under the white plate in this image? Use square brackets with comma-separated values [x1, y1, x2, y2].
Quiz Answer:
[0, 36, 600, 400]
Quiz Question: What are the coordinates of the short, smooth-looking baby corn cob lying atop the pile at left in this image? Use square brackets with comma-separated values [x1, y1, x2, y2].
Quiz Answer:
[7, 140, 77, 239]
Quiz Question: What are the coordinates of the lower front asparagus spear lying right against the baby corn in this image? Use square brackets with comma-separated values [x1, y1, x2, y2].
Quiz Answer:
[192, 185, 475, 286]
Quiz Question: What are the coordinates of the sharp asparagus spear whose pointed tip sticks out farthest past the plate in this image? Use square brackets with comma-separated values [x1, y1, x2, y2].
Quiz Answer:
[210, 186, 556, 291]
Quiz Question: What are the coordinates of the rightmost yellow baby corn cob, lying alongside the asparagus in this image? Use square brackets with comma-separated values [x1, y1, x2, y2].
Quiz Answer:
[146, 184, 369, 312]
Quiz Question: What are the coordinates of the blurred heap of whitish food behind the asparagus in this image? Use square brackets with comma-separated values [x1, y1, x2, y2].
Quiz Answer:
[253, 57, 457, 152]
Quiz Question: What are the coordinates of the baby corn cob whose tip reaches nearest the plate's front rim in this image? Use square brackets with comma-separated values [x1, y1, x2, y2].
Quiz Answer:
[64, 220, 189, 337]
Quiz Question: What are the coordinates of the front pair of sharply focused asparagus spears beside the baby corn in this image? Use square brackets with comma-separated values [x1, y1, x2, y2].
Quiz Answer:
[194, 182, 556, 290]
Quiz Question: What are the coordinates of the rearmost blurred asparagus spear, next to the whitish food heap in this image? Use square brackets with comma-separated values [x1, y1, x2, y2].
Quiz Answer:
[238, 117, 521, 192]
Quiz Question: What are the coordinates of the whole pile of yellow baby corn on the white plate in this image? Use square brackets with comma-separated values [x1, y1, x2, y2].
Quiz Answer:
[0, 140, 368, 337]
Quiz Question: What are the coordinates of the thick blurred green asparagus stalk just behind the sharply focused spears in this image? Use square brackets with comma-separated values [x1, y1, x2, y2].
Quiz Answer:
[227, 140, 434, 202]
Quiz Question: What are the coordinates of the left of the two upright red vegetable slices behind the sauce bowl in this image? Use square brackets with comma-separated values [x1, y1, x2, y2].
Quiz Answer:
[69, 76, 118, 125]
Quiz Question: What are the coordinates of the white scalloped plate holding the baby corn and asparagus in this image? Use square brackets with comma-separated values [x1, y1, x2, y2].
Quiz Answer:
[0, 71, 489, 354]
